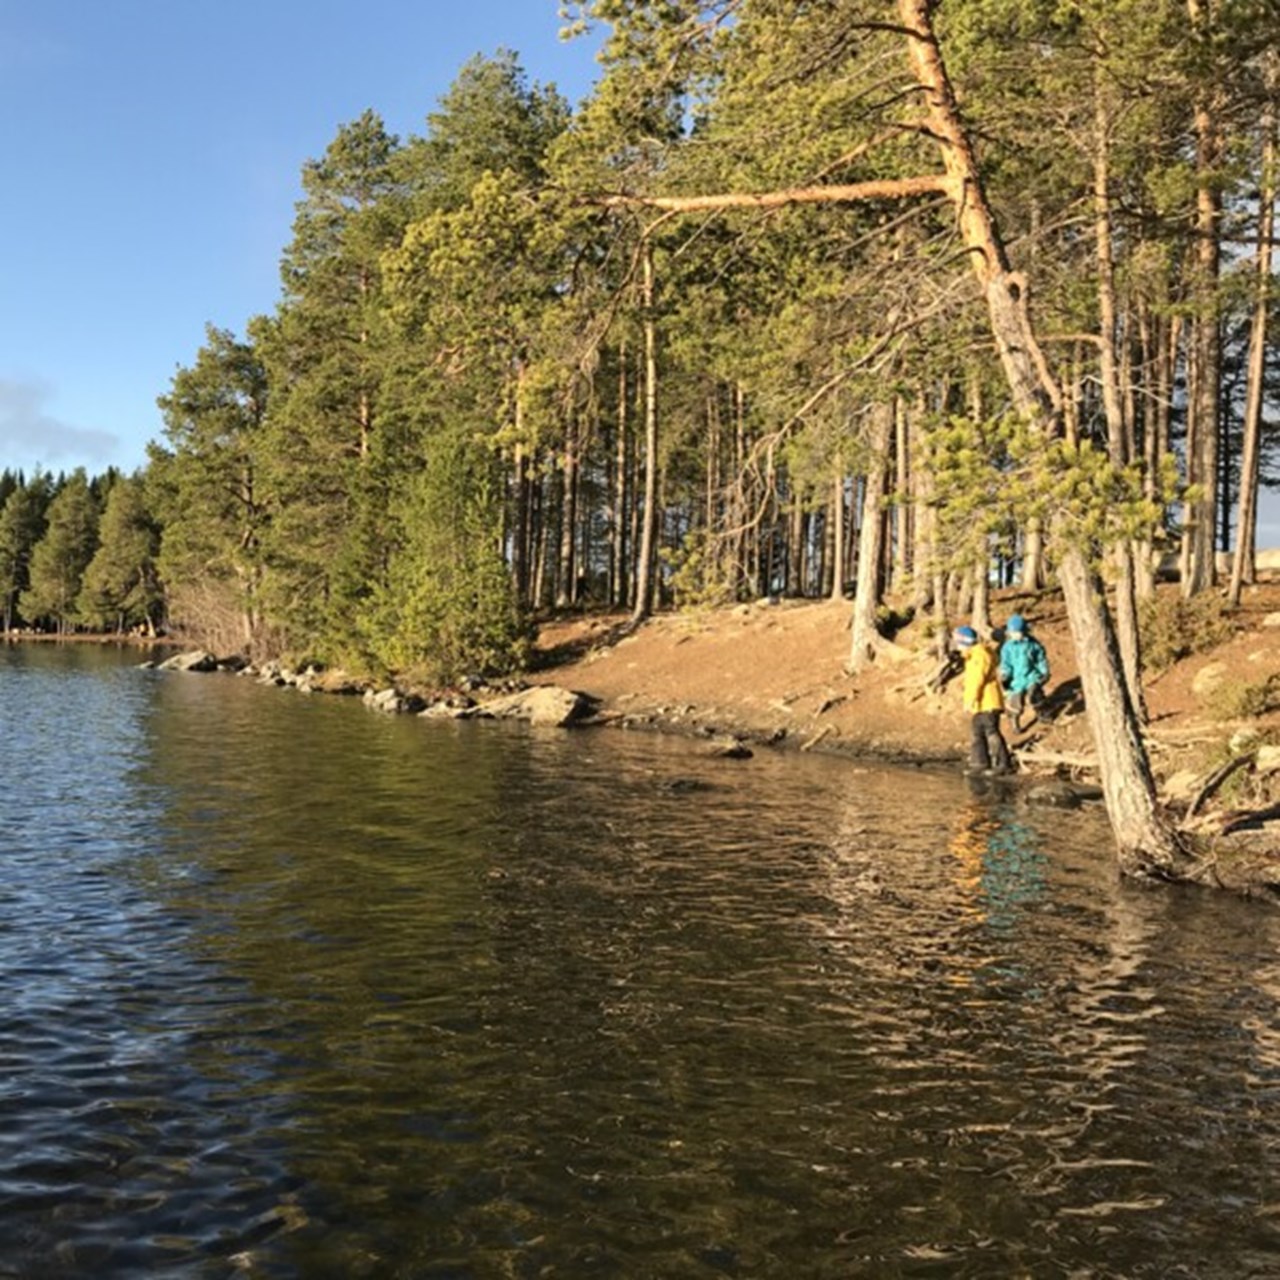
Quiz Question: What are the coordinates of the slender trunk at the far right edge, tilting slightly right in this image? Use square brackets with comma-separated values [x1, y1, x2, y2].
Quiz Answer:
[1226, 67, 1280, 608]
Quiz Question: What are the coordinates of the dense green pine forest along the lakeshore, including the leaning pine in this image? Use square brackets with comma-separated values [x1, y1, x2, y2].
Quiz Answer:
[0, 0, 1280, 868]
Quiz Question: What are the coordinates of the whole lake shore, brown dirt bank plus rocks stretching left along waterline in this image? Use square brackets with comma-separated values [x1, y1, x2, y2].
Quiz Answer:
[147, 584, 1280, 827]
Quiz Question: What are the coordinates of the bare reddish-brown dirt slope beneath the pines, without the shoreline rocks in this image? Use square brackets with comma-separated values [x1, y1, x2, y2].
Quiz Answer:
[534, 582, 1280, 787]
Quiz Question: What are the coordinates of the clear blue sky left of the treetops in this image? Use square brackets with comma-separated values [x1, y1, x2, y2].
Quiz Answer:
[0, 0, 598, 474]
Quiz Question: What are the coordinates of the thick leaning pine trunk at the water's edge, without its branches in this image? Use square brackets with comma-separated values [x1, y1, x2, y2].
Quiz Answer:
[897, 0, 1187, 874]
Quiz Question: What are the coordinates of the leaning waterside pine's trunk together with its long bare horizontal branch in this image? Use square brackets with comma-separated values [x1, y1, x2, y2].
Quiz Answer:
[570, 0, 1212, 879]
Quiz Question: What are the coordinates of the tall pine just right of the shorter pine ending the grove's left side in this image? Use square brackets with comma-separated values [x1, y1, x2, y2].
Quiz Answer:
[257, 111, 406, 657]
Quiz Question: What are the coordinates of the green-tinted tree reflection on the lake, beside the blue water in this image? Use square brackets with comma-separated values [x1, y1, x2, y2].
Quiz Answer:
[129, 676, 506, 1275]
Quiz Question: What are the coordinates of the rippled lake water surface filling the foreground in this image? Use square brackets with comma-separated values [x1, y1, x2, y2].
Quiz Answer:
[0, 646, 1280, 1280]
